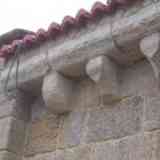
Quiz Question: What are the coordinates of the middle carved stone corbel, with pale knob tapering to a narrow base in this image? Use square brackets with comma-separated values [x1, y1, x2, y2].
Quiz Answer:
[86, 56, 120, 104]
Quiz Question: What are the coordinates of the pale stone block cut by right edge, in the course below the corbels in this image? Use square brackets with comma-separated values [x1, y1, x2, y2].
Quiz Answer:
[144, 96, 160, 131]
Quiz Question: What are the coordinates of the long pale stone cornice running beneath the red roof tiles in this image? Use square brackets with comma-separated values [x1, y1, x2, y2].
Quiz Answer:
[1, 2, 160, 97]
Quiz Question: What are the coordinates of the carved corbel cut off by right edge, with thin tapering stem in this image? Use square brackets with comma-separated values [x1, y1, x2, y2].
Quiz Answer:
[140, 32, 160, 83]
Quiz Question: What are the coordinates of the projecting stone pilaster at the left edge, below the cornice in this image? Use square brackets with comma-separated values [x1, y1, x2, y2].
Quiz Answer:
[0, 91, 30, 160]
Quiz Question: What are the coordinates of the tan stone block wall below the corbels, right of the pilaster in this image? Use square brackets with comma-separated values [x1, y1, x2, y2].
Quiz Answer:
[21, 61, 160, 160]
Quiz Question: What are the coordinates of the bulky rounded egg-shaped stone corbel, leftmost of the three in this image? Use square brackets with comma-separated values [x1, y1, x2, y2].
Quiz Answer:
[42, 71, 74, 114]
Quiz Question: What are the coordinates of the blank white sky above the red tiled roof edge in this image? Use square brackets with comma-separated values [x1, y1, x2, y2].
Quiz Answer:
[0, 0, 106, 34]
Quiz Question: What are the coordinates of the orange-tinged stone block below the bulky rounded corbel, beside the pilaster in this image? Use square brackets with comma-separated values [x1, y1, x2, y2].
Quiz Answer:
[25, 103, 59, 155]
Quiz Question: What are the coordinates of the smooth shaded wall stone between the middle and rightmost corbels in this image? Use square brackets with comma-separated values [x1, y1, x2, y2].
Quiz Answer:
[119, 60, 159, 96]
